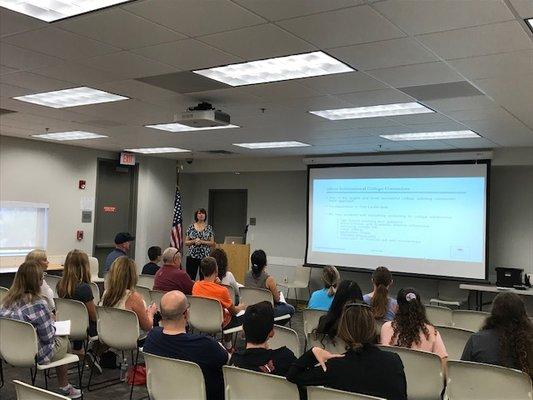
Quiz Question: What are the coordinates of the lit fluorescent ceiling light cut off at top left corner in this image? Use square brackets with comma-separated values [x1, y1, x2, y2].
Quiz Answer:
[0, 0, 130, 22]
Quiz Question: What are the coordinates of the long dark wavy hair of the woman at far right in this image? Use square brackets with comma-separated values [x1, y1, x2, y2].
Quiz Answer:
[481, 293, 533, 378]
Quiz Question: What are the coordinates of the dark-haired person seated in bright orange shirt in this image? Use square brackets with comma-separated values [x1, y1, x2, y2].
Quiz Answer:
[192, 257, 246, 329]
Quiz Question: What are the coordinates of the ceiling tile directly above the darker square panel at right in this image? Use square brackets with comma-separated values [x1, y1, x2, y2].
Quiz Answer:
[368, 62, 464, 87]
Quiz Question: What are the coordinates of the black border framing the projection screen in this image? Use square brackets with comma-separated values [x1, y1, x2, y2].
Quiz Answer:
[304, 159, 492, 283]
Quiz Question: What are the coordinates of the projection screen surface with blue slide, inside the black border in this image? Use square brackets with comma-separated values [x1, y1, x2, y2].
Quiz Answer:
[307, 165, 486, 279]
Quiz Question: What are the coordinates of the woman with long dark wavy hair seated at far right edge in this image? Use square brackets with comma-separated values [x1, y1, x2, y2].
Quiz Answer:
[461, 293, 533, 378]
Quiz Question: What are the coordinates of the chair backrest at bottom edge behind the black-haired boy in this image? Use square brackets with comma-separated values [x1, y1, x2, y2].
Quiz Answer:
[222, 365, 300, 400]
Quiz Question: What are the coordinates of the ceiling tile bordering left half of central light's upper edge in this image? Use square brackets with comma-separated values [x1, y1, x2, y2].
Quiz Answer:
[132, 39, 242, 70]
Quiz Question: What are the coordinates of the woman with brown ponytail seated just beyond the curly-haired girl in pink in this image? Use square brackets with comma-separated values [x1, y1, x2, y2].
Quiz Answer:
[363, 267, 398, 321]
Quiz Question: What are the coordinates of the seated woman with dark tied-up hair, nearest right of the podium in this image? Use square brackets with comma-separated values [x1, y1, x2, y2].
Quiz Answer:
[244, 250, 294, 323]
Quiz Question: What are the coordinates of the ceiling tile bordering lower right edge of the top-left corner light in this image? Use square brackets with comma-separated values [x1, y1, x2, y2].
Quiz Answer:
[57, 8, 186, 49]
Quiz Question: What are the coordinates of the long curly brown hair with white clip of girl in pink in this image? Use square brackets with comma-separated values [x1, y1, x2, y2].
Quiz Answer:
[390, 288, 431, 348]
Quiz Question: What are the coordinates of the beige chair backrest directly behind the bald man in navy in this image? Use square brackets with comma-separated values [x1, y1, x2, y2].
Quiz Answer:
[144, 353, 206, 400]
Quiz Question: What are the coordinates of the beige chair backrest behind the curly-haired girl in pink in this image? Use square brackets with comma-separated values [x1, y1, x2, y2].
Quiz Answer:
[380, 346, 444, 400]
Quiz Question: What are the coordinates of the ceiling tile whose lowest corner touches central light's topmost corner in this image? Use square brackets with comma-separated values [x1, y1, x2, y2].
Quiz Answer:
[278, 5, 405, 48]
